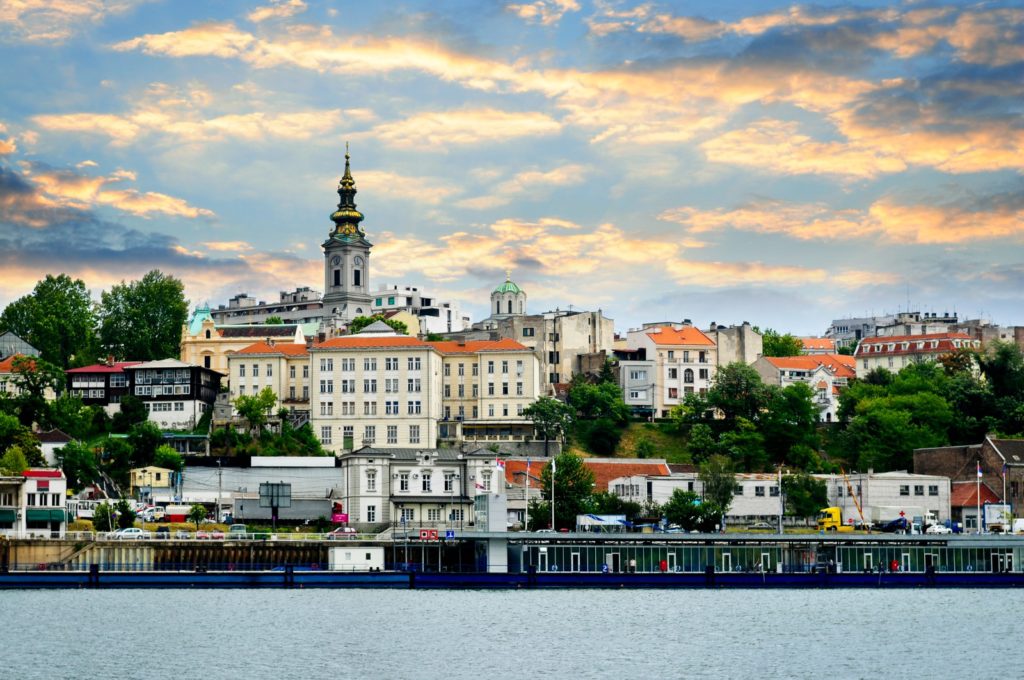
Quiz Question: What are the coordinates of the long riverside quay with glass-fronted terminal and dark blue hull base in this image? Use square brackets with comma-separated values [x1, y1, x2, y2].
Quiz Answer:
[0, 532, 1024, 589]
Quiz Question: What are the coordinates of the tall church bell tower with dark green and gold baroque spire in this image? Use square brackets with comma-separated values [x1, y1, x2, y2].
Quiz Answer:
[322, 143, 374, 328]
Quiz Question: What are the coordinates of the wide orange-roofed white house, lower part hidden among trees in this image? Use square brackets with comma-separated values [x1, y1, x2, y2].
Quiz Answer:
[752, 354, 855, 423]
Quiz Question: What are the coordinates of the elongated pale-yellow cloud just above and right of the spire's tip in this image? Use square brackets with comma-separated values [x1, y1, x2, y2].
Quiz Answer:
[370, 109, 561, 150]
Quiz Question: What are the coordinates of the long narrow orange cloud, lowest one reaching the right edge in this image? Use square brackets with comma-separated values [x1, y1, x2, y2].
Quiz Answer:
[658, 190, 1024, 245]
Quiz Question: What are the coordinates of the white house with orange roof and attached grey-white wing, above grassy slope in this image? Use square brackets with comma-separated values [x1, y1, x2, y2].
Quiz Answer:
[618, 323, 718, 418]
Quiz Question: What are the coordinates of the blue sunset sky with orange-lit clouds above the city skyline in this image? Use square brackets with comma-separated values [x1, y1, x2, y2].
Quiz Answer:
[0, 0, 1024, 335]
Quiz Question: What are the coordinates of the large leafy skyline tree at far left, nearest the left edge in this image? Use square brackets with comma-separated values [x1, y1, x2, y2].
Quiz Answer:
[0, 273, 96, 369]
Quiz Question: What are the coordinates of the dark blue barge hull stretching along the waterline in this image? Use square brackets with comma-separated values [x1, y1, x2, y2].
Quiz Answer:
[0, 569, 1024, 590]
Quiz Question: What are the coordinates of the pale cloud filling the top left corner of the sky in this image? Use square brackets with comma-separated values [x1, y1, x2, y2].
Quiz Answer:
[0, 0, 147, 42]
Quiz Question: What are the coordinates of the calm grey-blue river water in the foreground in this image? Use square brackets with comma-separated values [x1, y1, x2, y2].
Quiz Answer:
[0, 590, 1024, 680]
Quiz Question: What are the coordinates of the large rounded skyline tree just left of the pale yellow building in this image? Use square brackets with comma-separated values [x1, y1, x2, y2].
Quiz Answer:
[99, 269, 188, 362]
